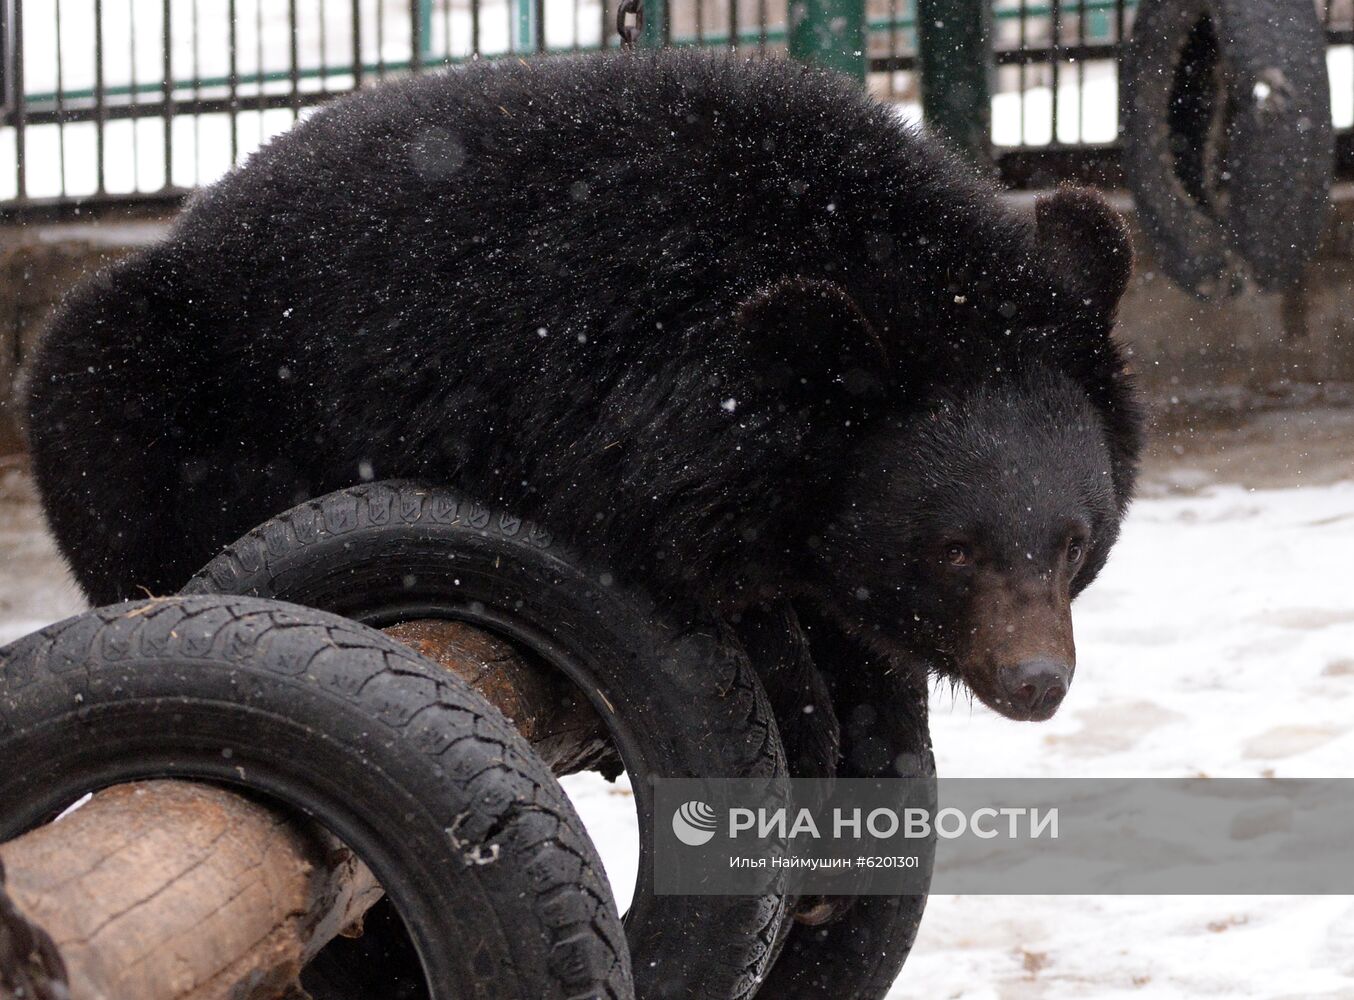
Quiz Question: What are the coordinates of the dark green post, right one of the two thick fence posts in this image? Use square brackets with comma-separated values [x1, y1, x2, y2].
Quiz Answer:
[917, 0, 992, 164]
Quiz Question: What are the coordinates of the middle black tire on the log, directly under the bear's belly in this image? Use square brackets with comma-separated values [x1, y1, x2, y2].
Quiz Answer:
[184, 482, 785, 1000]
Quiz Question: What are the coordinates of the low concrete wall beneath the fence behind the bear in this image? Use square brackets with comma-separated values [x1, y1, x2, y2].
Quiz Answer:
[0, 185, 1354, 455]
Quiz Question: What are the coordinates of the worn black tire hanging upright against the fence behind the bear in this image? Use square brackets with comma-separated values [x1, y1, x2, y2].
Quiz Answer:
[1120, 0, 1334, 299]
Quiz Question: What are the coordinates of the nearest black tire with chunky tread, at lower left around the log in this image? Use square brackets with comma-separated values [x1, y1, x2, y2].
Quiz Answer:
[0, 597, 634, 1000]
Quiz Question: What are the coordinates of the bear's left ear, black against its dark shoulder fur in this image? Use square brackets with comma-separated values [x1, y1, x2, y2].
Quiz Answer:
[737, 277, 888, 402]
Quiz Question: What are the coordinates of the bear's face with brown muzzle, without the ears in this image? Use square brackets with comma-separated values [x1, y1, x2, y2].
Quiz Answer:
[818, 368, 1120, 720]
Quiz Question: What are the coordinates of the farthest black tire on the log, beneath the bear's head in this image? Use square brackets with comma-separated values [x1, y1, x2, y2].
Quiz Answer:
[765, 612, 936, 1000]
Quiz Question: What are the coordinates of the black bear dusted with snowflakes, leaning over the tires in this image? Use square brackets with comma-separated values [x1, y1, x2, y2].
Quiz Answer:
[28, 51, 1140, 719]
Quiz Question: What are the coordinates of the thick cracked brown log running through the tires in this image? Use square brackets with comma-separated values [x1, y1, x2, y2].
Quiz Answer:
[0, 621, 611, 1000]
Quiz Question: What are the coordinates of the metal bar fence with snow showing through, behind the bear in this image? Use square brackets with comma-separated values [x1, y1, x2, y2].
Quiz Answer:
[0, 0, 1354, 215]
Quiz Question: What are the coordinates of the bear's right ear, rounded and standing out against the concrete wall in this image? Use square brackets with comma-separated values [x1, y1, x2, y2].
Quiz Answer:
[1034, 187, 1133, 318]
